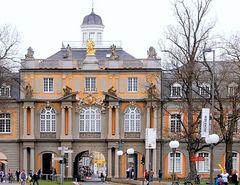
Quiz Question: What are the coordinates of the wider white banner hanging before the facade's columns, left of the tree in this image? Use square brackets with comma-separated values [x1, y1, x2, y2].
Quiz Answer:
[145, 128, 157, 149]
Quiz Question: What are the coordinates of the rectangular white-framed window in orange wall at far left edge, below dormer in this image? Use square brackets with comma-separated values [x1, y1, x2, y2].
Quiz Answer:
[0, 113, 12, 134]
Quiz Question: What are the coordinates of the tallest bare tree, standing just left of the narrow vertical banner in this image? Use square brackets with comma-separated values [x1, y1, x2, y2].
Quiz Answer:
[161, 0, 215, 178]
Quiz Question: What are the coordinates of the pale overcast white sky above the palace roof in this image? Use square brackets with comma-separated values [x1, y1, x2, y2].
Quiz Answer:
[0, 0, 240, 59]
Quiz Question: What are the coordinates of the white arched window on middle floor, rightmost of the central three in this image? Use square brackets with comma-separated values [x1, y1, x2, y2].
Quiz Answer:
[124, 107, 141, 132]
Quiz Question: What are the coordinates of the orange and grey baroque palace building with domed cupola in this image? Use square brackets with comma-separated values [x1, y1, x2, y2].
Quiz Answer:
[0, 7, 239, 179]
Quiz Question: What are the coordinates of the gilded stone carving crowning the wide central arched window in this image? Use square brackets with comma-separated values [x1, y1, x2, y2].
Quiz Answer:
[76, 94, 106, 112]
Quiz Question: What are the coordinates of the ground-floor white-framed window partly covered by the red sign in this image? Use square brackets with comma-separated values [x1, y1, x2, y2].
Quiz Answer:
[196, 151, 211, 173]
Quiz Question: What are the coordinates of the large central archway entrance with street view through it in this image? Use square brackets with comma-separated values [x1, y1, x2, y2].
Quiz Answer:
[74, 151, 107, 181]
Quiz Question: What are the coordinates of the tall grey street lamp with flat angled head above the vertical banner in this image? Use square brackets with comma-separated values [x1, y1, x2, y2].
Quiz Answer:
[203, 48, 215, 131]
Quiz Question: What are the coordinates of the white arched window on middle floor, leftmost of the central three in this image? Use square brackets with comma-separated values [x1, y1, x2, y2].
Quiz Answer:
[40, 107, 56, 132]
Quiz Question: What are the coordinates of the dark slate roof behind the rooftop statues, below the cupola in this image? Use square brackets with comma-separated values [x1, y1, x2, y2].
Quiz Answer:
[47, 48, 136, 60]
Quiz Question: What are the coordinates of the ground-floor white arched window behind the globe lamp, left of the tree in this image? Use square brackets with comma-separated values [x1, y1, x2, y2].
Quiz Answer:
[168, 151, 183, 173]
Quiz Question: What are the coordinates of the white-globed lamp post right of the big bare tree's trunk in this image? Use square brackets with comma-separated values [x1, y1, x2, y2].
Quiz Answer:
[205, 134, 219, 185]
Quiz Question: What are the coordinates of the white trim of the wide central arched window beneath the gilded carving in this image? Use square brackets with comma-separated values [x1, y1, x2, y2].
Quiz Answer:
[79, 107, 102, 133]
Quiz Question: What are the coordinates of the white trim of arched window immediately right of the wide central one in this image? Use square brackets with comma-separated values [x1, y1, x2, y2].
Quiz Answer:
[124, 107, 141, 132]
